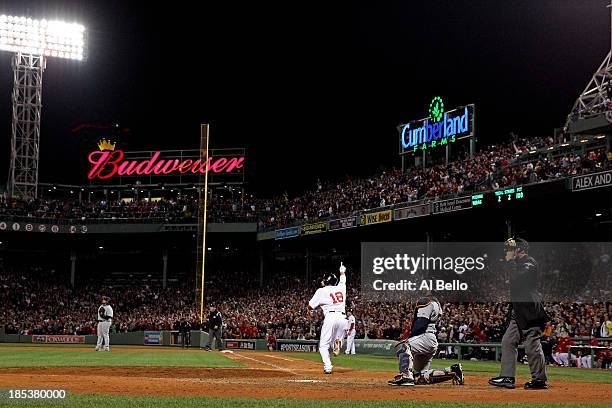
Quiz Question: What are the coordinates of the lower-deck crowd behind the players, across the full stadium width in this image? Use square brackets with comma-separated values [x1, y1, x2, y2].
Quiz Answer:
[0, 268, 612, 368]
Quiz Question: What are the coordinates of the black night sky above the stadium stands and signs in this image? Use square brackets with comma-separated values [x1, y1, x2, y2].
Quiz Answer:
[0, 0, 610, 195]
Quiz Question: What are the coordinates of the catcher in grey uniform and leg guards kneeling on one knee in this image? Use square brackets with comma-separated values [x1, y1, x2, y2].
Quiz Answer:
[388, 296, 464, 386]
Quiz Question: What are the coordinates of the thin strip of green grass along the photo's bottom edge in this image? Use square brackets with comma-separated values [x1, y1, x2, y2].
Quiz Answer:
[0, 394, 609, 408]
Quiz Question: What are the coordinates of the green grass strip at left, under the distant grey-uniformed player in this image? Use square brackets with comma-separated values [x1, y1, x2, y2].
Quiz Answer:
[0, 346, 244, 368]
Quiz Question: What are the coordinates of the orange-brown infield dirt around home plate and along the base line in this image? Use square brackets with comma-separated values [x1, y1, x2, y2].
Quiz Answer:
[0, 346, 612, 403]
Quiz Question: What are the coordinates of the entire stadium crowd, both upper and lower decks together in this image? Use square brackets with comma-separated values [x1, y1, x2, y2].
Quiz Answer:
[0, 135, 612, 368]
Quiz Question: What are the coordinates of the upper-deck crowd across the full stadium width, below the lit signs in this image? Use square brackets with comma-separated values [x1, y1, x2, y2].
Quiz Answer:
[0, 138, 609, 230]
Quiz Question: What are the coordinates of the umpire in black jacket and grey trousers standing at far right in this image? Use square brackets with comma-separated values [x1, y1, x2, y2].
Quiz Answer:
[489, 238, 548, 389]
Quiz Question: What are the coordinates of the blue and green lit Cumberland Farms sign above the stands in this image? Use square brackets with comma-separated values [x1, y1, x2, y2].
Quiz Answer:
[398, 97, 474, 155]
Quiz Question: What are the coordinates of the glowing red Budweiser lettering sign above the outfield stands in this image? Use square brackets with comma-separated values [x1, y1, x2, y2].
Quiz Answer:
[87, 150, 244, 180]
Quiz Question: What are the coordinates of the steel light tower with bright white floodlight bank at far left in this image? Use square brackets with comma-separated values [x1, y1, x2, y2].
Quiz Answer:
[0, 15, 85, 198]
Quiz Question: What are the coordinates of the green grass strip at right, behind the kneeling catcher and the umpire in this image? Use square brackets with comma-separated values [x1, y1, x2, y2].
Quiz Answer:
[291, 353, 612, 384]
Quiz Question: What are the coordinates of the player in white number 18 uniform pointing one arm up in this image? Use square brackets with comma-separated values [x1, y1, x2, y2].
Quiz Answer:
[308, 263, 346, 374]
